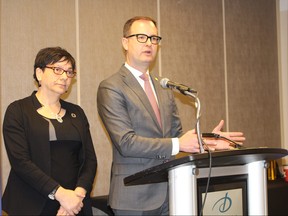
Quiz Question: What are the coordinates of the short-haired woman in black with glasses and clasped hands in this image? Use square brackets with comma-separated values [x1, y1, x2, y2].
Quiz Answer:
[2, 47, 97, 215]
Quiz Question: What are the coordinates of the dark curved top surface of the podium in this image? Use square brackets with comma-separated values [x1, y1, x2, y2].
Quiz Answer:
[124, 147, 288, 186]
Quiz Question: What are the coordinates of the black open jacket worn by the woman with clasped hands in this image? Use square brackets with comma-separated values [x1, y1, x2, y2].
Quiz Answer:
[2, 92, 97, 215]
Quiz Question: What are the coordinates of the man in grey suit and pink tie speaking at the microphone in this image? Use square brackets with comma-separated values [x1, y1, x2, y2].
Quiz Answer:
[97, 17, 244, 215]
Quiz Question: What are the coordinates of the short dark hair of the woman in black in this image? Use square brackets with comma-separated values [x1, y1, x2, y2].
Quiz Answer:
[33, 47, 76, 86]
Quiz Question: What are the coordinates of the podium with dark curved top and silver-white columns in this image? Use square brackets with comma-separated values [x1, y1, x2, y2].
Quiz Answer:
[124, 147, 288, 215]
